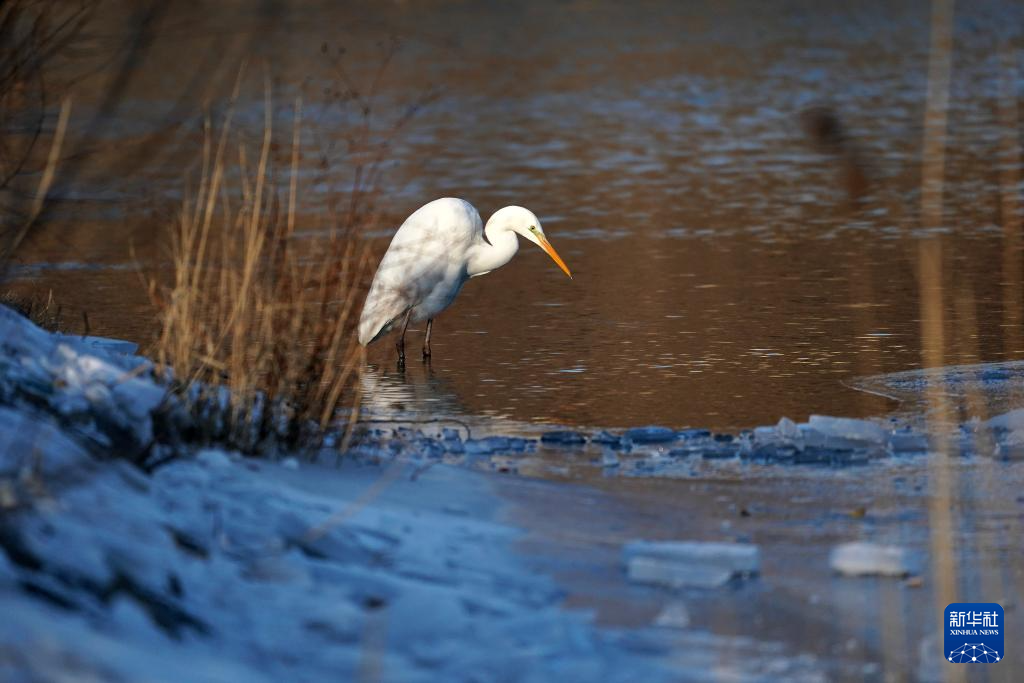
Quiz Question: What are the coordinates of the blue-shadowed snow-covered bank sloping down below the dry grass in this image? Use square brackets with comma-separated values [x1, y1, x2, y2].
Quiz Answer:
[0, 308, 700, 681]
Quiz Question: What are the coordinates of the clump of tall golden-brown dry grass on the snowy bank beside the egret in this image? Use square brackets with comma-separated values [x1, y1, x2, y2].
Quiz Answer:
[151, 89, 369, 453]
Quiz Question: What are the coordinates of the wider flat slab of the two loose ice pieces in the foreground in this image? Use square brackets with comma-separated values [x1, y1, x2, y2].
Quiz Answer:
[623, 541, 761, 589]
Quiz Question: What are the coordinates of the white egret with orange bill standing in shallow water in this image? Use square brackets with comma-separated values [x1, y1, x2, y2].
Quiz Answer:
[359, 198, 572, 361]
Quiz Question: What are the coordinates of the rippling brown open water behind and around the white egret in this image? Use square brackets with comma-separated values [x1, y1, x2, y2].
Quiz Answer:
[12, 1, 1024, 429]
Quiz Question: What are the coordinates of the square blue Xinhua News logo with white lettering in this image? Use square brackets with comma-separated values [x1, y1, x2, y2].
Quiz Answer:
[942, 602, 1006, 664]
